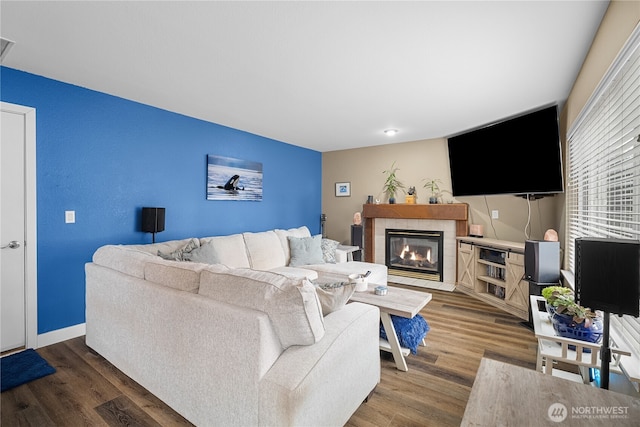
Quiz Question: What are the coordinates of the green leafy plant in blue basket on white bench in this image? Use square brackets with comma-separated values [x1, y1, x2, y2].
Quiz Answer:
[542, 286, 603, 343]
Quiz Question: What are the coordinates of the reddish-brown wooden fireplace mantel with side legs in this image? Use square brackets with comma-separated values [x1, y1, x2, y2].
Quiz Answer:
[362, 203, 469, 262]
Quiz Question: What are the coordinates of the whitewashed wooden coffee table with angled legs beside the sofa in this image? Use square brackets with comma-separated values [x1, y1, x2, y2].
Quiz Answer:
[351, 283, 431, 372]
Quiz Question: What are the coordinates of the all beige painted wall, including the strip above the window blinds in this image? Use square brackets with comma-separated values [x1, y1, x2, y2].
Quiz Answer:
[322, 1, 640, 251]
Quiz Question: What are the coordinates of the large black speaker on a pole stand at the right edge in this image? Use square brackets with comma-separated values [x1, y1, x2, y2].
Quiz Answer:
[575, 238, 640, 317]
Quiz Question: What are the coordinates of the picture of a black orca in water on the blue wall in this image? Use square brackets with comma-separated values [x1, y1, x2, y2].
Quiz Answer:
[207, 154, 262, 201]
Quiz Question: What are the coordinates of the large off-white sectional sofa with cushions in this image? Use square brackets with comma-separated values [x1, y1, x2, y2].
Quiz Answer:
[86, 227, 386, 426]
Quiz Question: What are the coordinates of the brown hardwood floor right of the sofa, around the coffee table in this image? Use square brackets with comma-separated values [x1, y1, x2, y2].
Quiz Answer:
[347, 291, 537, 427]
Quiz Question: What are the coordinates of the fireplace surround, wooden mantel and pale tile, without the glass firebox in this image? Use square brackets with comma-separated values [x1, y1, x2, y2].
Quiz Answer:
[363, 204, 467, 290]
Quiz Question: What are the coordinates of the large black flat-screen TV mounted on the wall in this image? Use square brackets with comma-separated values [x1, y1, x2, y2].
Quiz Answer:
[448, 105, 564, 198]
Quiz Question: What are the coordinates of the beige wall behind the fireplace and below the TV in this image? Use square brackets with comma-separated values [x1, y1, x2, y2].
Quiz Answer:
[322, 138, 557, 243]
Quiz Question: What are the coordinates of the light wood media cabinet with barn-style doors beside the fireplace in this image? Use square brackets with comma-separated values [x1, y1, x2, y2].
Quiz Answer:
[456, 237, 529, 320]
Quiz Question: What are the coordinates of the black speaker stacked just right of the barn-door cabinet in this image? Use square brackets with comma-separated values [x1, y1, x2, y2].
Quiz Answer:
[524, 240, 560, 284]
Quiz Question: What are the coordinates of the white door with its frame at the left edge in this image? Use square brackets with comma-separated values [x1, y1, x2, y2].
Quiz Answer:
[0, 103, 37, 351]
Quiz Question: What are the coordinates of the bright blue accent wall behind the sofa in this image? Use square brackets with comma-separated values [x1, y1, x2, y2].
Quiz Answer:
[0, 67, 322, 333]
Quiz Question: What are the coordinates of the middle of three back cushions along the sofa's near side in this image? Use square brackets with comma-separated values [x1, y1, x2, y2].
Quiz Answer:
[144, 259, 211, 293]
